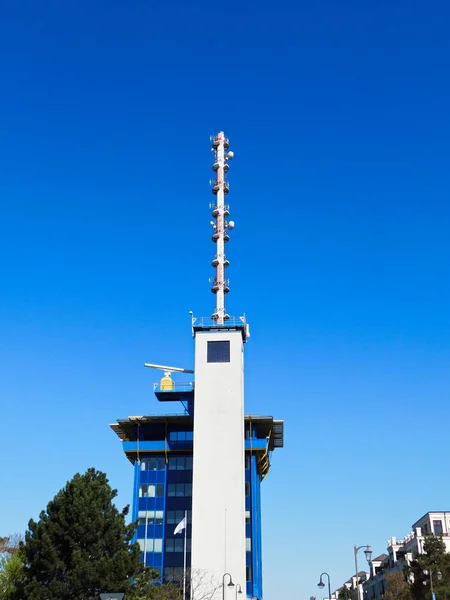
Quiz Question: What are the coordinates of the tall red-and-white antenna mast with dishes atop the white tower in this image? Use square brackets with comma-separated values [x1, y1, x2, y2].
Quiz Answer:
[210, 131, 234, 325]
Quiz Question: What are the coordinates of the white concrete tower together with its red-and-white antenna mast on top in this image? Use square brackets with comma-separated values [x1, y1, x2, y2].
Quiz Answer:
[191, 132, 249, 600]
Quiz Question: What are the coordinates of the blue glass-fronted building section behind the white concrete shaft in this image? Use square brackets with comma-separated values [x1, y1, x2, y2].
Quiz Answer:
[111, 411, 283, 599]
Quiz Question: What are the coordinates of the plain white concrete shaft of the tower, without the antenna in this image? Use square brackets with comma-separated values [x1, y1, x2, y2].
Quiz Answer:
[191, 331, 246, 600]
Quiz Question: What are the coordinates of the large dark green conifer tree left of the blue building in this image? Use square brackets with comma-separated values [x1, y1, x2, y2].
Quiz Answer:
[14, 469, 140, 600]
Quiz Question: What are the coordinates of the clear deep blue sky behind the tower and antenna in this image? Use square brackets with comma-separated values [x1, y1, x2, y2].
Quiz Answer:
[0, 0, 450, 600]
